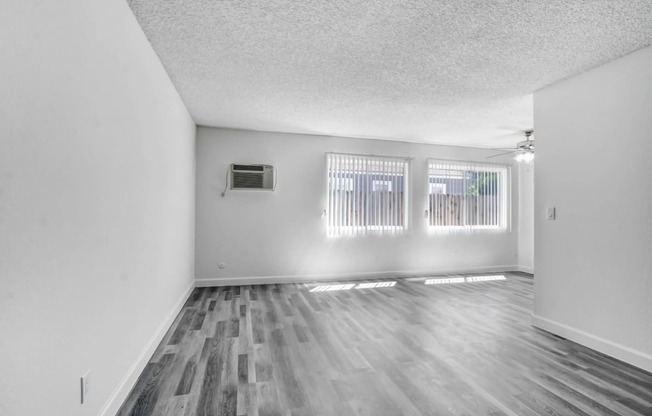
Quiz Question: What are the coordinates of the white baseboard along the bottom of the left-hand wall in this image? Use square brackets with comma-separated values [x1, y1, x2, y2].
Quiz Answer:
[99, 283, 195, 416]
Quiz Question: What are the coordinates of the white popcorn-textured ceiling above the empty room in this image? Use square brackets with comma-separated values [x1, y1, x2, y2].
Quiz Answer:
[130, 0, 652, 147]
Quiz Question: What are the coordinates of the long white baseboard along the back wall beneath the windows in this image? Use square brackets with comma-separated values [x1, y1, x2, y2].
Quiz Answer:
[195, 265, 519, 287]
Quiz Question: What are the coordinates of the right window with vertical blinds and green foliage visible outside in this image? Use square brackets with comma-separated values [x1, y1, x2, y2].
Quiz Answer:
[428, 159, 509, 232]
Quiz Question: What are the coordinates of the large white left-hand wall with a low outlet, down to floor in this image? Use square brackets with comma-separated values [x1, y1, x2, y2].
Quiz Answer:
[0, 0, 195, 416]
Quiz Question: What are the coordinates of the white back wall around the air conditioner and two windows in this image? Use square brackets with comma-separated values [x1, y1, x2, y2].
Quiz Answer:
[196, 127, 518, 284]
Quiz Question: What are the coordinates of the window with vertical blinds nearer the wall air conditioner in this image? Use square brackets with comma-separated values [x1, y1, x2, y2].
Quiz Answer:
[327, 154, 408, 236]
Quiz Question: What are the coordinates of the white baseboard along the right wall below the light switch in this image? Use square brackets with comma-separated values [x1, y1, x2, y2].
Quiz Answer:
[532, 314, 652, 372]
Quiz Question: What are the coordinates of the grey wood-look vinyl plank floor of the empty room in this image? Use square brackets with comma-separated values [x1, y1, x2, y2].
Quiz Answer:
[118, 273, 652, 416]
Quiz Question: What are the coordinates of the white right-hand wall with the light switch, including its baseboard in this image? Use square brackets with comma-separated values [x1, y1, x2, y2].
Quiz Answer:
[534, 47, 652, 371]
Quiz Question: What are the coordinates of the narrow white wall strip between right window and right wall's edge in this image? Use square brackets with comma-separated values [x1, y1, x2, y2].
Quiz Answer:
[518, 162, 536, 273]
